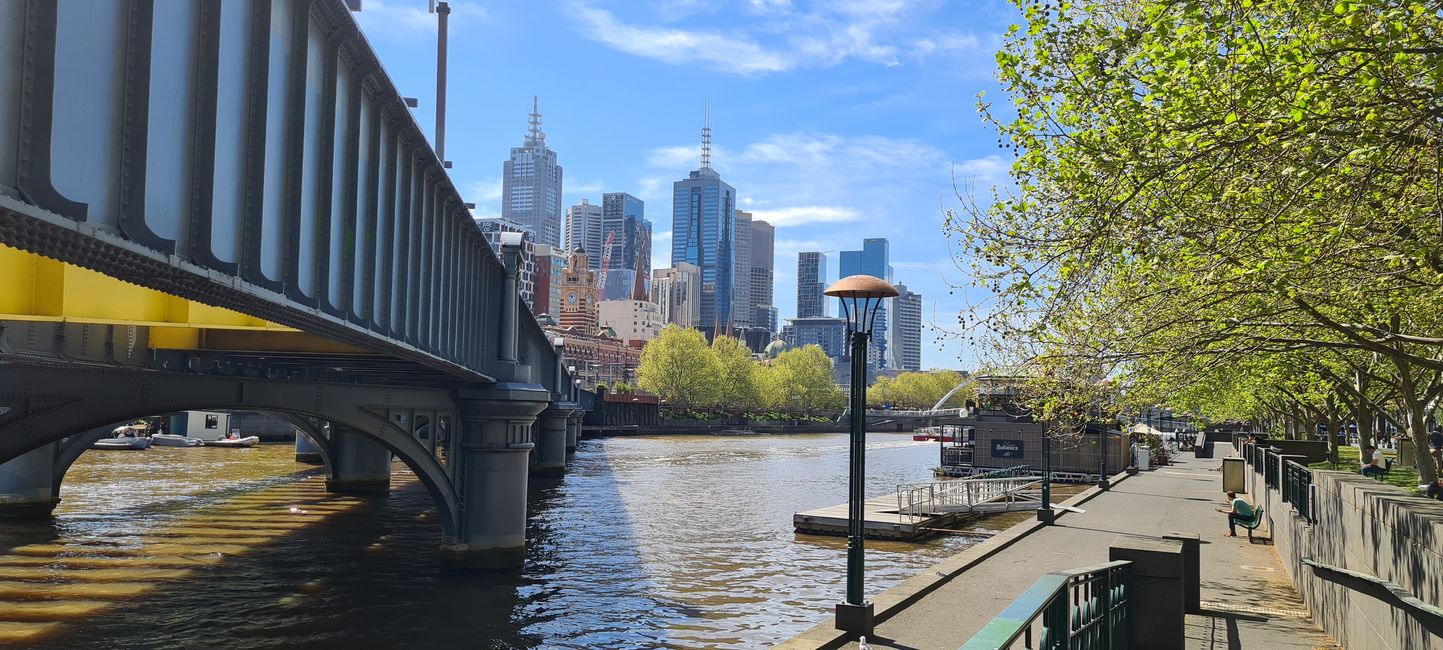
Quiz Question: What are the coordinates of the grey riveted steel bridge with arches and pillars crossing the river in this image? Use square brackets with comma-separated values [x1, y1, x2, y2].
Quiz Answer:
[0, 0, 580, 566]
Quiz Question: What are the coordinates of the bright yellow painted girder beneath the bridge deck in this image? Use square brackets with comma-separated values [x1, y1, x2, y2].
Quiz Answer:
[0, 244, 365, 354]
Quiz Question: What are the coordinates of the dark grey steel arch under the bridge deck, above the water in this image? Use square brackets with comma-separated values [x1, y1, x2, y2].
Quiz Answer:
[0, 365, 460, 539]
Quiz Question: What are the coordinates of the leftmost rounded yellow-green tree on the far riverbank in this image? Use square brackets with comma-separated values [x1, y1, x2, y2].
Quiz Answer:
[636, 325, 723, 409]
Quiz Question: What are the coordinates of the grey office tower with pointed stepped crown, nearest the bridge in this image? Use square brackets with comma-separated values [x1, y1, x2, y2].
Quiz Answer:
[501, 97, 561, 246]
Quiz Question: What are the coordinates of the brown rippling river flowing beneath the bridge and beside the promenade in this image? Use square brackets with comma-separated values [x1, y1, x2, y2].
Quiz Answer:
[0, 433, 975, 649]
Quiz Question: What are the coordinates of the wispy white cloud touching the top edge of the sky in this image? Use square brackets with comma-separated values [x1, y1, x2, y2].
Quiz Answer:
[559, 0, 983, 77]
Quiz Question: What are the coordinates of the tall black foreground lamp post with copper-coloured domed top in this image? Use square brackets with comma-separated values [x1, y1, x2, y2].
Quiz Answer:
[823, 276, 898, 636]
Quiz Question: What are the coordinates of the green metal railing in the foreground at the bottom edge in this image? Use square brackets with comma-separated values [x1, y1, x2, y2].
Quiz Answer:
[962, 560, 1133, 650]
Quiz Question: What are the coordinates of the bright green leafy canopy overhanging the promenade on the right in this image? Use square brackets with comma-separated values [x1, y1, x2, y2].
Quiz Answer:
[947, 0, 1443, 480]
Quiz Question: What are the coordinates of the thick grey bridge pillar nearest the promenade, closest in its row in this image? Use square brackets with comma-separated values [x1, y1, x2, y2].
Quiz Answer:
[443, 384, 548, 568]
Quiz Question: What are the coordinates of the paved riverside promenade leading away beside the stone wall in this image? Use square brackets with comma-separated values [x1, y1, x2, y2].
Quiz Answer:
[779, 443, 1338, 650]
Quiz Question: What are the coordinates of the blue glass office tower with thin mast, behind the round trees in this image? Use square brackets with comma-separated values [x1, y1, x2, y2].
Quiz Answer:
[671, 107, 736, 335]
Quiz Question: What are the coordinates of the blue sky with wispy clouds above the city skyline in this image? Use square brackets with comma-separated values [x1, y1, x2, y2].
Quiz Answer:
[358, 0, 1017, 368]
